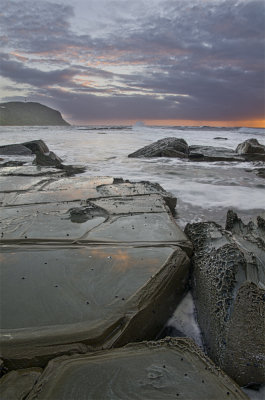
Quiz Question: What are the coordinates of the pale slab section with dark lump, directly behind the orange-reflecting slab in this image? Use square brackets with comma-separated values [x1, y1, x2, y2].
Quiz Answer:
[0, 191, 192, 255]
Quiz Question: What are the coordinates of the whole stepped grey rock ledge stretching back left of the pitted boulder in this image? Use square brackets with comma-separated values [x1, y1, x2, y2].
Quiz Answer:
[0, 162, 192, 369]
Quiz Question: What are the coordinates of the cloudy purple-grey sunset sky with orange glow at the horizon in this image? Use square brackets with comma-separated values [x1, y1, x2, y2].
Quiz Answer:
[0, 0, 265, 127]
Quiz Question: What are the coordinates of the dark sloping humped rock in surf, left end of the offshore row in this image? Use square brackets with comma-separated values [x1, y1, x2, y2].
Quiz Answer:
[128, 137, 189, 158]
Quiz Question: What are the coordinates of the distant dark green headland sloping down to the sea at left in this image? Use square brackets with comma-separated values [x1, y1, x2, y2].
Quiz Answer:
[0, 101, 69, 125]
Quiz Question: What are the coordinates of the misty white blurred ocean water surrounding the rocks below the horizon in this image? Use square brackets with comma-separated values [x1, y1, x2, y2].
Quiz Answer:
[0, 123, 265, 228]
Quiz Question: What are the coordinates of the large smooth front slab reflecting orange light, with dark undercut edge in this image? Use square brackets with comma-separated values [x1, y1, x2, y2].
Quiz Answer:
[0, 245, 189, 366]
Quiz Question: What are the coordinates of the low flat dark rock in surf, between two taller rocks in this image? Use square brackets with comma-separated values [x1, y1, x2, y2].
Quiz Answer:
[189, 146, 244, 161]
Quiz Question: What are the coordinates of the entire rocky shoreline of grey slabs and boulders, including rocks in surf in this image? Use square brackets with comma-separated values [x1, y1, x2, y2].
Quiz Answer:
[0, 138, 265, 400]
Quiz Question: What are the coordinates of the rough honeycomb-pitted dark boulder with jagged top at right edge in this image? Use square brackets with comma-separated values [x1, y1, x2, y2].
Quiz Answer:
[185, 212, 265, 385]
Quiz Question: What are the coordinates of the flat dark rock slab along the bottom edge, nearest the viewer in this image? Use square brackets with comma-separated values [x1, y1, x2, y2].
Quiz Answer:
[27, 338, 245, 400]
